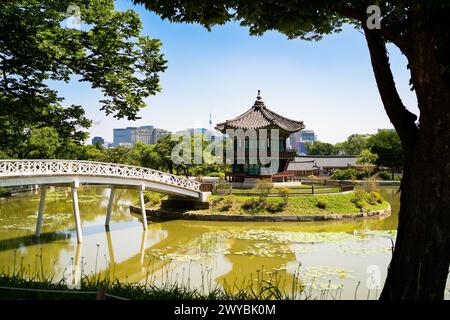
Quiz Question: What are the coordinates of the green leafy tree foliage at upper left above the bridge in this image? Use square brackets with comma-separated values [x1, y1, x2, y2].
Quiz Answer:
[0, 0, 165, 157]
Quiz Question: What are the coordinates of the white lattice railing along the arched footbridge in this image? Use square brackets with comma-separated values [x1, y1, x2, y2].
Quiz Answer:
[0, 160, 201, 191]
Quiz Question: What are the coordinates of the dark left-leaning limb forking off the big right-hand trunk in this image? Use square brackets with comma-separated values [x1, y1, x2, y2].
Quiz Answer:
[363, 24, 418, 152]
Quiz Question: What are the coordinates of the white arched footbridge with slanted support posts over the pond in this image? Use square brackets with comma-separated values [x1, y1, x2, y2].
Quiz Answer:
[0, 160, 209, 242]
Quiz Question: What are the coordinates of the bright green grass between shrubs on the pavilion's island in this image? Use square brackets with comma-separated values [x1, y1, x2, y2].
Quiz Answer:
[189, 193, 389, 215]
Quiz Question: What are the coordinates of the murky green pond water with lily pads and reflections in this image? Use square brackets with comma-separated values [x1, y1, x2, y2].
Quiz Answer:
[0, 187, 450, 299]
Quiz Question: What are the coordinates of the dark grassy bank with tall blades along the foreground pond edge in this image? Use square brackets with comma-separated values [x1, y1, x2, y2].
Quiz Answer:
[0, 273, 306, 300]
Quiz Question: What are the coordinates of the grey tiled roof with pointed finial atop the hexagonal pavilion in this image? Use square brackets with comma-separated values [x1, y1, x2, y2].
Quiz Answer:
[216, 90, 305, 133]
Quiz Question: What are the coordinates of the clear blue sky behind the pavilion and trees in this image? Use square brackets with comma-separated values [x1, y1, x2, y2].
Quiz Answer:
[55, 0, 417, 143]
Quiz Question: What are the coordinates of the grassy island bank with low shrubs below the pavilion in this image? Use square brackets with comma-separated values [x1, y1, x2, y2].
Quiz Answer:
[189, 189, 389, 215]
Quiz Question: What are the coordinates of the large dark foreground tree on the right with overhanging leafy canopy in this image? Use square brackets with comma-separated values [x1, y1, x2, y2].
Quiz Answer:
[134, 0, 450, 299]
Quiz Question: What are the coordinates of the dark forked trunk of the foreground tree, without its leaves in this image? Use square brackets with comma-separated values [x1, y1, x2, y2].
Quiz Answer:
[363, 26, 450, 300]
